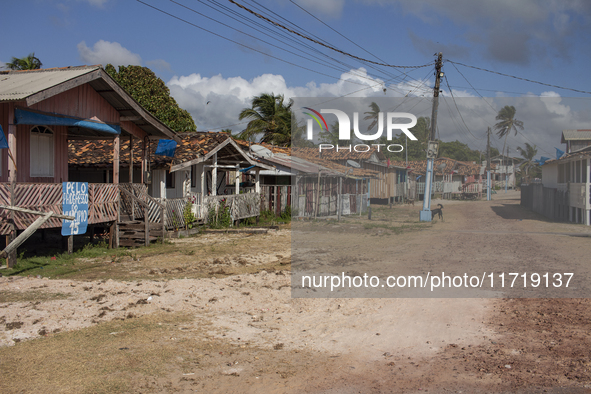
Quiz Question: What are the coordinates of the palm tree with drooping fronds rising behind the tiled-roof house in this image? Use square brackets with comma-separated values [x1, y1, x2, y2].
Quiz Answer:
[239, 93, 293, 146]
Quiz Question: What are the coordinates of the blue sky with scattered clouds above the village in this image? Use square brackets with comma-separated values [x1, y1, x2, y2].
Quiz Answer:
[0, 0, 591, 157]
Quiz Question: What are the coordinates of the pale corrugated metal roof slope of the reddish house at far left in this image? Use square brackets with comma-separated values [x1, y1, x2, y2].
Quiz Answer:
[0, 66, 100, 101]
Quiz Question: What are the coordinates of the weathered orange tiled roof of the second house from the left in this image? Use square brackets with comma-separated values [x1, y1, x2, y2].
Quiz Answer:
[68, 132, 245, 167]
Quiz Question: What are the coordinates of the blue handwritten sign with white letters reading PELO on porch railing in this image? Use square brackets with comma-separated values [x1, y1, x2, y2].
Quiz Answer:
[62, 182, 88, 235]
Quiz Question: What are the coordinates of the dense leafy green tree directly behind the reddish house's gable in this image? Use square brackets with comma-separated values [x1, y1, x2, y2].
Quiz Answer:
[105, 64, 197, 133]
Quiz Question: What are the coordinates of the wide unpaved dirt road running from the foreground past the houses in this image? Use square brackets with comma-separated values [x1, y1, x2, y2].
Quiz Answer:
[0, 194, 591, 393]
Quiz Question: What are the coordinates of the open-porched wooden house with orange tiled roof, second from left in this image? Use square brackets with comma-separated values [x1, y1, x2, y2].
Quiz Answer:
[69, 132, 271, 227]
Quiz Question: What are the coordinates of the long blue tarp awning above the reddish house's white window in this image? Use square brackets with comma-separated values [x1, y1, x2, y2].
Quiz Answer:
[14, 108, 121, 134]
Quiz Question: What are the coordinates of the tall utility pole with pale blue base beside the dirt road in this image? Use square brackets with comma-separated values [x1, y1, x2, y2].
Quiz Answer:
[419, 52, 443, 222]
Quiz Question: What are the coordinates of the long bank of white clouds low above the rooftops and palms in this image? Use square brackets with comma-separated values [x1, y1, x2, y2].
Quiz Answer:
[167, 68, 591, 156]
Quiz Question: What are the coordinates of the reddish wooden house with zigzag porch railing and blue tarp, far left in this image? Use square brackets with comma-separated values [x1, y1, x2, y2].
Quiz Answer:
[0, 66, 178, 255]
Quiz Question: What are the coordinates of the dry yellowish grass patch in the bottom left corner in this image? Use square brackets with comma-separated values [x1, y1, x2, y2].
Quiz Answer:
[0, 314, 192, 393]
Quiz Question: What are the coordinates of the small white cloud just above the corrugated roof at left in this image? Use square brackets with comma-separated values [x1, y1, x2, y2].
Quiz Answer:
[78, 40, 142, 66]
